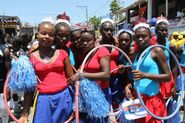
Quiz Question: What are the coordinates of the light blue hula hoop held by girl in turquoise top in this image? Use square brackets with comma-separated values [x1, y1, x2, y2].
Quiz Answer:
[136, 45, 184, 120]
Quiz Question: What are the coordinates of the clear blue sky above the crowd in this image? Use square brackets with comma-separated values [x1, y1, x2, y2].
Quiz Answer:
[0, 0, 132, 25]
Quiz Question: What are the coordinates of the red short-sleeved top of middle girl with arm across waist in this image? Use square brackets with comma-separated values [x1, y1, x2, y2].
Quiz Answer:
[84, 47, 110, 89]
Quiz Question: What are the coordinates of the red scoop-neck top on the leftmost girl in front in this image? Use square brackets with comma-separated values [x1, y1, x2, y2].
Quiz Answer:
[30, 50, 68, 94]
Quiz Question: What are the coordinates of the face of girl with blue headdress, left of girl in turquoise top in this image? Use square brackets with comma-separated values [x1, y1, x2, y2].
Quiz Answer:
[118, 32, 132, 50]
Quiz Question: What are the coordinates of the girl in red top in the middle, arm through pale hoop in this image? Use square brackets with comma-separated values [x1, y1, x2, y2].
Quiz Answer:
[69, 31, 111, 123]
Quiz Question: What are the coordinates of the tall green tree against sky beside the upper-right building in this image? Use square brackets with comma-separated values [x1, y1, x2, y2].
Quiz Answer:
[110, 0, 123, 22]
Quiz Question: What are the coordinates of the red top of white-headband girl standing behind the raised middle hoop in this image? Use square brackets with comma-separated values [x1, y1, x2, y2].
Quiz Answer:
[110, 49, 119, 76]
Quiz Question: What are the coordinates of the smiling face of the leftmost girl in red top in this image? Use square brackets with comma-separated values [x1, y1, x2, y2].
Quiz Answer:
[38, 23, 54, 47]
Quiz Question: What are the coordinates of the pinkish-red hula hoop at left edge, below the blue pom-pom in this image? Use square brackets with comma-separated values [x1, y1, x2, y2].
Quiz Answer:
[3, 72, 19, 123]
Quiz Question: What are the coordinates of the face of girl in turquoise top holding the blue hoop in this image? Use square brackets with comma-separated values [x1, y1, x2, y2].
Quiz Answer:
[135, 27, 151, 50]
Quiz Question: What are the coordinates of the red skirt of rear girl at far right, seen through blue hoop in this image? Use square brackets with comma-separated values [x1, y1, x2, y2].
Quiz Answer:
[159, 73, 175, 99]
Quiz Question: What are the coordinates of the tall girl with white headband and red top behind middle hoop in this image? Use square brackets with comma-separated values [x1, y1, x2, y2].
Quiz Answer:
[98, 18, 119, 109]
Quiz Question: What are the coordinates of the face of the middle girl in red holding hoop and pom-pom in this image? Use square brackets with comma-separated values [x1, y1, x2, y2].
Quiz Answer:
[80, 32, 95, 53]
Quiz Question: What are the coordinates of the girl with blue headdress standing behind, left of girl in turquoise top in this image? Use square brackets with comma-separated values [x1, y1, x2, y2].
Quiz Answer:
[116, 29, 134, 123]
